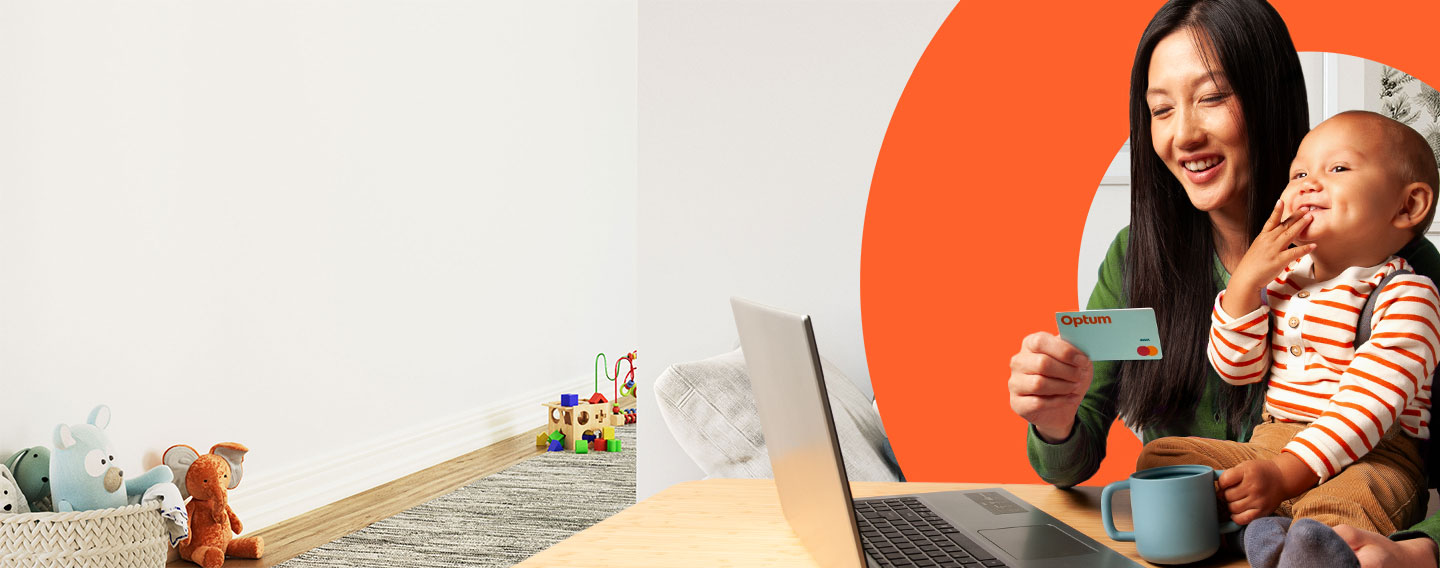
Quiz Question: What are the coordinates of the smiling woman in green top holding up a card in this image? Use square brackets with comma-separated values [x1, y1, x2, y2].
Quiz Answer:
[1009, 0, 1440, 567]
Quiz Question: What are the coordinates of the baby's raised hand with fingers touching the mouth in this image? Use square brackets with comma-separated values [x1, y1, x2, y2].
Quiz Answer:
[1220, 202, 1315, 317]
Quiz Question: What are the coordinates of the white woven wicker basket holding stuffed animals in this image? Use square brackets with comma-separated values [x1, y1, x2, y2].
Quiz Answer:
[0, 502, 170, 568]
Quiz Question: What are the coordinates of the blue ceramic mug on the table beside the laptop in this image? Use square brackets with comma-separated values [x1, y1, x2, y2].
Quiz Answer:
[1100, 466, 1240, 564]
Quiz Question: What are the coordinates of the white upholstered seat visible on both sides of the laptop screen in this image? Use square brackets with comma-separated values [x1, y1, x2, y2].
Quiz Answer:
[655, 349, 900, 482]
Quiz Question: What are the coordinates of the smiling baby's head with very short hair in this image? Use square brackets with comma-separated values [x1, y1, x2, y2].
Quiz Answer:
[1280, 115, 1404, 249]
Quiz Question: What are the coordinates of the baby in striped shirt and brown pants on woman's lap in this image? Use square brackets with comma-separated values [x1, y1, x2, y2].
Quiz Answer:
[1139, 112, 1440, 565]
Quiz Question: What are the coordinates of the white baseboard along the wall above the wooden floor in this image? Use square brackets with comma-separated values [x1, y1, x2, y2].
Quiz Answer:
[230, 381, 580, 533]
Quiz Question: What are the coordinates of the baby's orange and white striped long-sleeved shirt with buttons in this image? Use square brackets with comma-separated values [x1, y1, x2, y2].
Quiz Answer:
[1207, 255, 1440, 482]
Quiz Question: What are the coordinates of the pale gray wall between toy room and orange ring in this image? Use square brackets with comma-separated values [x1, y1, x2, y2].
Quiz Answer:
[636, 0, 955, 499]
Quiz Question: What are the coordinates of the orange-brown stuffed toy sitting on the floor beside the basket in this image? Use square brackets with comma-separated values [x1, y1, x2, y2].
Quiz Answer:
[161, 443, 265, 568]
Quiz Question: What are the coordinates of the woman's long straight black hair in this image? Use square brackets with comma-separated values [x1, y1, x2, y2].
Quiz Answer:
[1117, 0, 1309, 432]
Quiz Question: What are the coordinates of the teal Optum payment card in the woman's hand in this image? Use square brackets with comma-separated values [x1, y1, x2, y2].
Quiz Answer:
[1056, 307, 1165, 360]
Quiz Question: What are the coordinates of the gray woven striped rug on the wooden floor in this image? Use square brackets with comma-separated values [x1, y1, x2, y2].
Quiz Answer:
[281, 424, 635, 568]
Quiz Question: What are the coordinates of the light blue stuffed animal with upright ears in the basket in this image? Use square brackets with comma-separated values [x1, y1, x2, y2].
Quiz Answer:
[50, 405, 174, 513]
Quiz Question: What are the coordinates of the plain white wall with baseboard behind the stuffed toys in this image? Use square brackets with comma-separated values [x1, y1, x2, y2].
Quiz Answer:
[0, 0, 639, 528]
